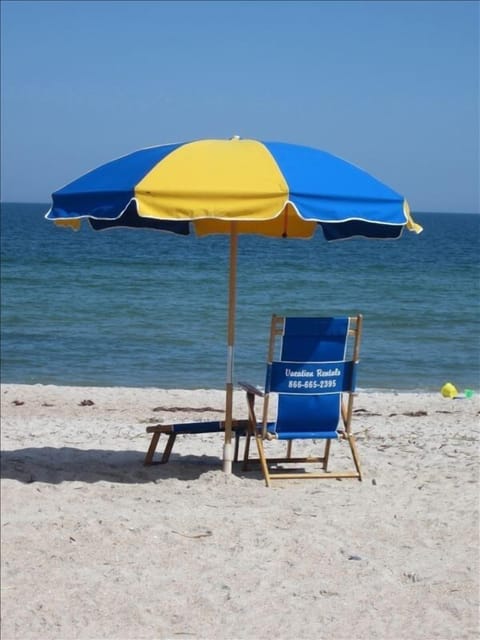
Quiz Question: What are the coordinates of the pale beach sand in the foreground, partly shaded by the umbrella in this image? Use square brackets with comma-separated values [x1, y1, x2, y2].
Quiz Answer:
[1, 384, 480, 640]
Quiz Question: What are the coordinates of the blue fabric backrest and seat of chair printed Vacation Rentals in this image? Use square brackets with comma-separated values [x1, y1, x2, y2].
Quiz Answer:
[263, 316, 362, 439]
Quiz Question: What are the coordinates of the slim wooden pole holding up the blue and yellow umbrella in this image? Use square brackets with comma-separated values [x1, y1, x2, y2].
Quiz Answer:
[223, 222, 238, 473]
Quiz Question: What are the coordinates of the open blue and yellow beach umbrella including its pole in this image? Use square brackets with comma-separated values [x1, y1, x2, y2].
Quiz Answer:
[46, 136, 421, 473]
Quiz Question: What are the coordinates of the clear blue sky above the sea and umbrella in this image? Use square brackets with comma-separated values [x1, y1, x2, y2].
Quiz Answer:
[1, 0, 479, 212]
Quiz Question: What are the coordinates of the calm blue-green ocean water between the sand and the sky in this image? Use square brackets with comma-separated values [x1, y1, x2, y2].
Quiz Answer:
[0, 203, 480, 392]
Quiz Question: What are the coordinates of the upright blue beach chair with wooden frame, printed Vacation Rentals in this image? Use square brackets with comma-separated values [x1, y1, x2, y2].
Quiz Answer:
[240, 315, 362, 486]
